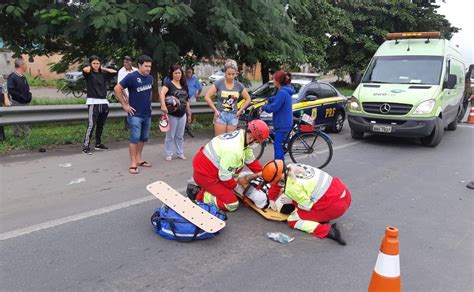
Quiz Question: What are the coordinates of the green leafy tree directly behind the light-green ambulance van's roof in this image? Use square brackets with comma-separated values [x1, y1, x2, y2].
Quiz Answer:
[327, 0, 458, 84]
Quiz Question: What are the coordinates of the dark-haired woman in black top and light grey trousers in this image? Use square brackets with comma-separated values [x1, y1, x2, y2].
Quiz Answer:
[160, 64, 191, 161]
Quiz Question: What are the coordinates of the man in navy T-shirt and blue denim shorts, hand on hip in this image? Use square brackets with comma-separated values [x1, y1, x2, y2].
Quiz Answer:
[114, 55, 153, 174]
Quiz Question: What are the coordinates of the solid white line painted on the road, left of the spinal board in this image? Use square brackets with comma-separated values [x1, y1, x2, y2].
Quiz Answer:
[0, 187, 186, 241]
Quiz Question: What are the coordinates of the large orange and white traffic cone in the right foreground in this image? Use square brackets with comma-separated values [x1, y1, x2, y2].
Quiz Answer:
[369, 226, 402, 292]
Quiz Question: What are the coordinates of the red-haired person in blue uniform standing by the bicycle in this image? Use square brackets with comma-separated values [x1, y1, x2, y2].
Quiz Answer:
[262, 70, 295, 160]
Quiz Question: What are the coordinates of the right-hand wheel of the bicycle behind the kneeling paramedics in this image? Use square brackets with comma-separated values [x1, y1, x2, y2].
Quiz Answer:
[288, 132, 333, 168]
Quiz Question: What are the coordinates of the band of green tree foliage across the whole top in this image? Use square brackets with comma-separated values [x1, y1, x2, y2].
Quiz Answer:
[0, 0, 458, 85]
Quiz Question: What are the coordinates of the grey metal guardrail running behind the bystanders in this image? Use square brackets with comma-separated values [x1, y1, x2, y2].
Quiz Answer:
[0, 102, 212, 126]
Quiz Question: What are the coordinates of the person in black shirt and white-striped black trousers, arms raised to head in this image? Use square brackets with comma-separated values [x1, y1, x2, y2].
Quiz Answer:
[82, 56, 117, 155]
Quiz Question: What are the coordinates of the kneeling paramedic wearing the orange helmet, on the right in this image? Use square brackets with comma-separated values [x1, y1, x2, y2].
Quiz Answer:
[262, 160, 351, 245]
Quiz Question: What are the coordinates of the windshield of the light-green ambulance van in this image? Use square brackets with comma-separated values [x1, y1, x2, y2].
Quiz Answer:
[362, 56, 443, 85]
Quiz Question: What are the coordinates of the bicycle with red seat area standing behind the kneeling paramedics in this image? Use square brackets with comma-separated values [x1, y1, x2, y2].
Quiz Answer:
[241, 110, 333, 168]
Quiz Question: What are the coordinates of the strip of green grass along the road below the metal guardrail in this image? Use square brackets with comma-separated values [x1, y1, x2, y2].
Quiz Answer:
[0, 114, 213, 155]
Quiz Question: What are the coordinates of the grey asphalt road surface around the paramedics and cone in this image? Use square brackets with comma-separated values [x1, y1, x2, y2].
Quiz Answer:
[0, 126, 474, 291]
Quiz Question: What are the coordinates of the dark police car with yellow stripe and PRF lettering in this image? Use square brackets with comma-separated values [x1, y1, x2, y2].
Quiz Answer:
[240, 73, 347, 133]
